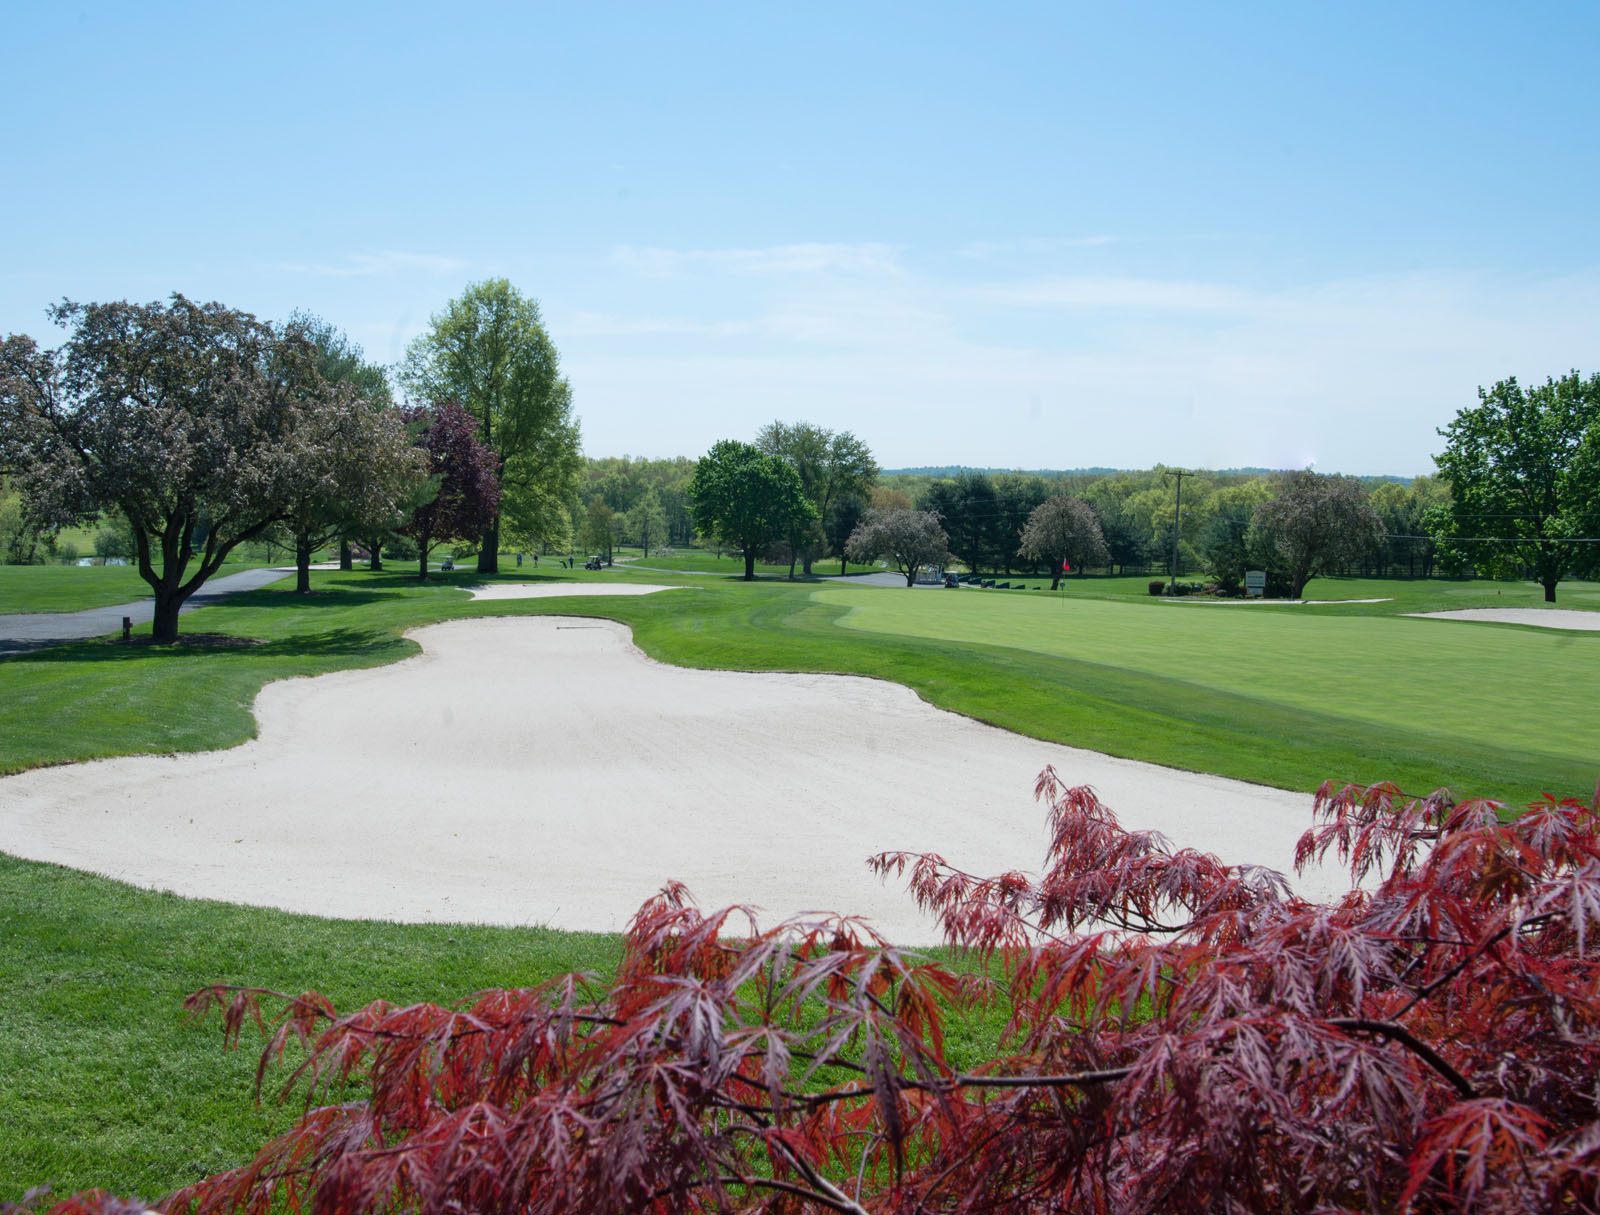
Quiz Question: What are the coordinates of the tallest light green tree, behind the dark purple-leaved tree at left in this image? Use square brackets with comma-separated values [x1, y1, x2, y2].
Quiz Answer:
[400, 279, 582, 573]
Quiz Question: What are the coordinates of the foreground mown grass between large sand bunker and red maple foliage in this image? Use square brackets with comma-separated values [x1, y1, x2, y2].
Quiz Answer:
[0, 855, 621, 1202]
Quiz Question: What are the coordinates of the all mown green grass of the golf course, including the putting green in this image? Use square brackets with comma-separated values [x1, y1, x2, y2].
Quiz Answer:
[0, 567, 1600, 1199]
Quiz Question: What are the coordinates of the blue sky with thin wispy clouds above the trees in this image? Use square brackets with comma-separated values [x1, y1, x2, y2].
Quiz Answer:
[0, 0, 1600, 474]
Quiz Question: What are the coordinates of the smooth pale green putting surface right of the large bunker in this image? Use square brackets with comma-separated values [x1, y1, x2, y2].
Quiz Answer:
[814, 586, 1600, 777]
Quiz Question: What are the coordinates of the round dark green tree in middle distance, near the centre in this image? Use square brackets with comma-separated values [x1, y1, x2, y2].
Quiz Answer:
[690, 439, 816, 581]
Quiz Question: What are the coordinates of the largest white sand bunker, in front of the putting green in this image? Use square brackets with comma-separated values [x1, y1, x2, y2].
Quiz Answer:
[0, 616, 1333, 943]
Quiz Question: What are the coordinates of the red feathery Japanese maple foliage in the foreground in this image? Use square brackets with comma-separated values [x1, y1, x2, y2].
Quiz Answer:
[28, 770, 1600, 1215]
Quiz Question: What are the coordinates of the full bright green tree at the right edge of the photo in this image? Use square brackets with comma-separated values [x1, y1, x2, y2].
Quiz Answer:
[1432, 371, 1600, 603]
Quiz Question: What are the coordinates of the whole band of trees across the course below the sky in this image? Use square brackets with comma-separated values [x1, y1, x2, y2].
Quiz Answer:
[0, 279, 1600, 617]
